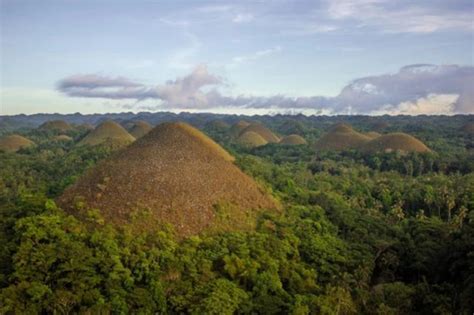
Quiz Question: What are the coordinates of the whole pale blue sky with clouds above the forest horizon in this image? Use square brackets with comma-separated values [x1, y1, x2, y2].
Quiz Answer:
[0, 0, 474, 115]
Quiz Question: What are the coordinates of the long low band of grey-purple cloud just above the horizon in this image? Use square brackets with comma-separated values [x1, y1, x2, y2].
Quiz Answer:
[58, 64, 474, 114]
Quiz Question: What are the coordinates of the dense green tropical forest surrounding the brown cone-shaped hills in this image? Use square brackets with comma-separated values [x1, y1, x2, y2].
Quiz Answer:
[0, 114, 474, 314]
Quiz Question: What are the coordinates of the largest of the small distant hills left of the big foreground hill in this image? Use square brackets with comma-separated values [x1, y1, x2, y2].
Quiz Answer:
[77, 120, 135, 146]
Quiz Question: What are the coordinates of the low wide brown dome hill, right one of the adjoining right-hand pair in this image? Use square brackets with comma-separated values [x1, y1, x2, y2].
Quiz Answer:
[362, 132, 431, 153]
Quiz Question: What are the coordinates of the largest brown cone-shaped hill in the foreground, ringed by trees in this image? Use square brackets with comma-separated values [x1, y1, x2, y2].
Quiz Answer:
[58, 123, 277, 237]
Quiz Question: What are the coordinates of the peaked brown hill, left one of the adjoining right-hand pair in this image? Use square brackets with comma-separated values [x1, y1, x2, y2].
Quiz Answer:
[314, 123, 370, 151]
